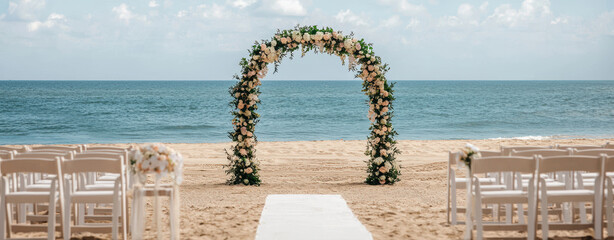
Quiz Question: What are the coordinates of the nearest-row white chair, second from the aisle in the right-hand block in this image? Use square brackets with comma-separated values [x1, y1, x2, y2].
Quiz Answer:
[536, 155, 604, 239]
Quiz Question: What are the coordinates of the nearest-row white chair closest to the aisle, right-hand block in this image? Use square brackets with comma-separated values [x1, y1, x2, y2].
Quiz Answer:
[471, 156, 535, 239]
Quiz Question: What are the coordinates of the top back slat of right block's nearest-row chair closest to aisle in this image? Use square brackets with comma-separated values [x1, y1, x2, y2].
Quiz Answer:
[471, 156, 535, 174]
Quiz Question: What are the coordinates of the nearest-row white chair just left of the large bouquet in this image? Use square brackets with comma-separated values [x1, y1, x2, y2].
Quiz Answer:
[62, 158, 127, 239]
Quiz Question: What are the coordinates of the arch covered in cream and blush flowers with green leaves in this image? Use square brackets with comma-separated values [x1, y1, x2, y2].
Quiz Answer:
[226, 26, 400, 185]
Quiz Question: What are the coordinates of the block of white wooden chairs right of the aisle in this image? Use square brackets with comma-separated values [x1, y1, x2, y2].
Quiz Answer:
[448, 144, 614, 238]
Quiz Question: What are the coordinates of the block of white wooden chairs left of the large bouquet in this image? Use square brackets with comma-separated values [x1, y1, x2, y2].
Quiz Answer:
[0, 145, 129, 239]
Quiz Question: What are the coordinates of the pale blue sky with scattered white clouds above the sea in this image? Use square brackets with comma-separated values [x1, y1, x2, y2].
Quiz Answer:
[0, 0, 614, 80]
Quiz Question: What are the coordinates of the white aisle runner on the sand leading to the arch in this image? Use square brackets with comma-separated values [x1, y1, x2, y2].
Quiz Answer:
[256, 194, 373, 240]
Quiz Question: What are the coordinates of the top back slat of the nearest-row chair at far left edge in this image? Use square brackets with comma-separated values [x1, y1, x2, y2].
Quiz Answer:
[0, 158, 59, 175]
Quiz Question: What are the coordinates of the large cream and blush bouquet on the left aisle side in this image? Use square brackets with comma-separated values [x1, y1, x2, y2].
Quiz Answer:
[128, 143, 183, 184]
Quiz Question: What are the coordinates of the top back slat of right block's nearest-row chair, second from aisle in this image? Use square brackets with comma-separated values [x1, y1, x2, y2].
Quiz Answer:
[539, 155, 601, 173]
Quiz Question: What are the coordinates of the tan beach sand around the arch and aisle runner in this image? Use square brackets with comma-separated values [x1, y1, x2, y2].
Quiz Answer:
[6, 139, 614, 239]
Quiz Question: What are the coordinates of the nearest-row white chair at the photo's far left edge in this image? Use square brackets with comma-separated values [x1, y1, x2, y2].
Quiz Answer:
[0, 158, 64, 239]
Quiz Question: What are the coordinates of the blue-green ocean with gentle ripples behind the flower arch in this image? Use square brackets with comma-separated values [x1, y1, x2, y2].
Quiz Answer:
[0, 80, 614, 145]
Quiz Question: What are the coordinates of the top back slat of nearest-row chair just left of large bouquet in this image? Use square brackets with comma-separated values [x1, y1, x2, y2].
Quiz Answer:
[62, 158, 123, 174]
